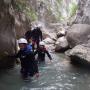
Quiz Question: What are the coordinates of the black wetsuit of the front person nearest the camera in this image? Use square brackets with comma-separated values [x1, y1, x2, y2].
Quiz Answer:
[16, 47, 38, 77]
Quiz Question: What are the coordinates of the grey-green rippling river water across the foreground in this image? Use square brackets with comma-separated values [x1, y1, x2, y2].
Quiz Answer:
[0, 53, 90, 90]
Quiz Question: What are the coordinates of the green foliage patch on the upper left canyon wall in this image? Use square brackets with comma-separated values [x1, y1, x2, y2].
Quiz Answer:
[15, 0, 37, 21]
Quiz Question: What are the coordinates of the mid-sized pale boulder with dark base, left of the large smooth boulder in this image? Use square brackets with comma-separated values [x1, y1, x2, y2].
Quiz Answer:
[55, 36, 68, 52]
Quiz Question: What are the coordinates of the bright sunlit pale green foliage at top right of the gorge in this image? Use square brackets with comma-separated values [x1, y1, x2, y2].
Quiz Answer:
[55, 0, 78, 21]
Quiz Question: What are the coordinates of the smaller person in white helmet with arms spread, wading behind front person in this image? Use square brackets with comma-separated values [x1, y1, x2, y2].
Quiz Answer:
[34, 42, 52, 63]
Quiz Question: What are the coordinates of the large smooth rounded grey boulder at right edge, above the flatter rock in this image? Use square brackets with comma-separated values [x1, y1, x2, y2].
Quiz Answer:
[67, 24, 90, 48]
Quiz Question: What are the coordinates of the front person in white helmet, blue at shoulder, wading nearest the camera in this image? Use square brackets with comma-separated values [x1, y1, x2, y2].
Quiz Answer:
[16, 38, 39, 78]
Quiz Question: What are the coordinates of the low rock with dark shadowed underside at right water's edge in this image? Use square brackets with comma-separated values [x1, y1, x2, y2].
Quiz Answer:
[68, 45, 90, 64]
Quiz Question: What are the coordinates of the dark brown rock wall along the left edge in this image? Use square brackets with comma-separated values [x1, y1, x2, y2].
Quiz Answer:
[0, 0, 16, 68]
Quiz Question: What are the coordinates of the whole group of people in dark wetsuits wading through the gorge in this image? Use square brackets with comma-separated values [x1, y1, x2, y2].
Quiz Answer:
[15, 26, 52, 79]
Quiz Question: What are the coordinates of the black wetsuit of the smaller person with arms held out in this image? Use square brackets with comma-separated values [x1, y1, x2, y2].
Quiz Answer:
[34, 48, 52, 62]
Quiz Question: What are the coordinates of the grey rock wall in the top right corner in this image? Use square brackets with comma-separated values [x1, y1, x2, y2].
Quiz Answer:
[75, 0, 90, 24]
